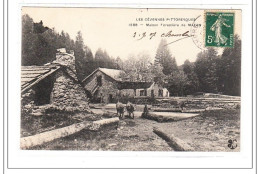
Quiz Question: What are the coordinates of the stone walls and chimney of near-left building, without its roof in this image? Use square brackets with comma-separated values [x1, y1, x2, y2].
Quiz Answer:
[21, 53, 89, 113]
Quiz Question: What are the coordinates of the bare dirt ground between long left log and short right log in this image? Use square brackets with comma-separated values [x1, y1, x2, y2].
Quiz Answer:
[33, 118, 172, 151]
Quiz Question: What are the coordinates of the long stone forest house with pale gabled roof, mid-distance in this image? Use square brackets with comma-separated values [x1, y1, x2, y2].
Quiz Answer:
[82, 68, 169, 103]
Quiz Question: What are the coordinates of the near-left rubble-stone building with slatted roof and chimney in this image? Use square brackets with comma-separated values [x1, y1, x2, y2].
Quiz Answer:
[21, 53, 90, 111]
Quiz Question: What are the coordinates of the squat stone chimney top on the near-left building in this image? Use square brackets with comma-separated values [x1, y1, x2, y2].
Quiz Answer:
[55, 48, 76, 72]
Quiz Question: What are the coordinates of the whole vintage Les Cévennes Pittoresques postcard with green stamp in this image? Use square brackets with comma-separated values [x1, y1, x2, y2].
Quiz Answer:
[20, 7, 242, 152]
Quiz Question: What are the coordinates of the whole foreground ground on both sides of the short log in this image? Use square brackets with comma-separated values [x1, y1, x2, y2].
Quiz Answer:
[32, 106, 240, 151]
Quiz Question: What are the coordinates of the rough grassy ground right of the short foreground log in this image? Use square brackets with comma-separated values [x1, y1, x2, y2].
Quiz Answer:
[159, 109, 240, 152]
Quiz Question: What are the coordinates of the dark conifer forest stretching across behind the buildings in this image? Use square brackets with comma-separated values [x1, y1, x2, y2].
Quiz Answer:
[21, 15, 241, 96]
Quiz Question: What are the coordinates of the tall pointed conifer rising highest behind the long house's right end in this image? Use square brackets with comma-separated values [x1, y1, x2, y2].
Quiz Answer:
[154, 39, 178, 75]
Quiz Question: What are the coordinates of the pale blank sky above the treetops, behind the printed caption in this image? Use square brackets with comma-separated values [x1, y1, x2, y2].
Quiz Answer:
[22, 7, 241, 65]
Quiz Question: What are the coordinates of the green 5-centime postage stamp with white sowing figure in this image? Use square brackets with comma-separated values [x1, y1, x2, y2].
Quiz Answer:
[205, 12, 235, 47]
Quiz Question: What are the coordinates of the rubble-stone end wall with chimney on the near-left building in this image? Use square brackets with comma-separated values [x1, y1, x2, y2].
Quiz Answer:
[51, 53, 89, 111]
